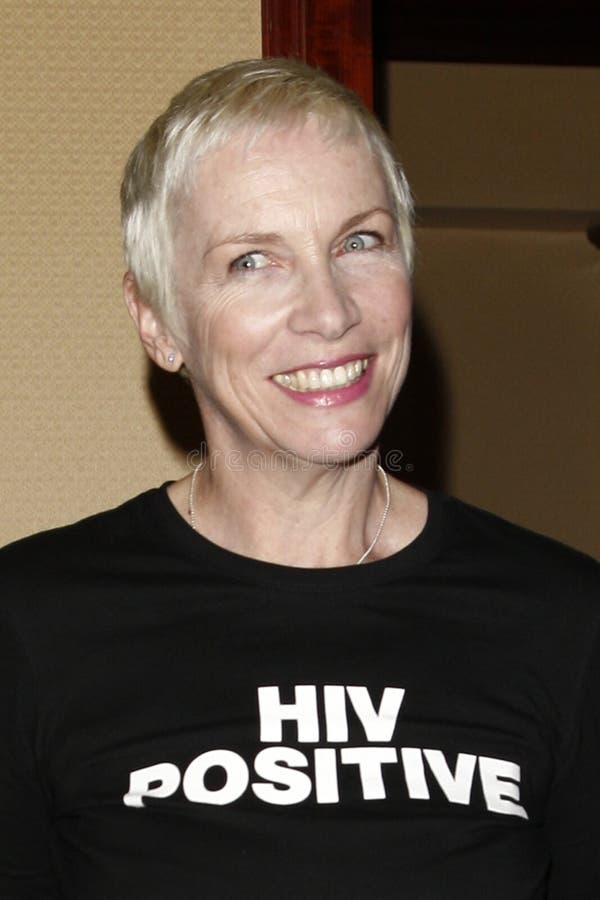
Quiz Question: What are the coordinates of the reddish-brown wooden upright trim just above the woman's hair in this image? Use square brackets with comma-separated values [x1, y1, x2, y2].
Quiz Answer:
[262, 0, 373, 106]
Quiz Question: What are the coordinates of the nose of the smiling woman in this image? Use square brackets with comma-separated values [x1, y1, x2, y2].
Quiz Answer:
[288, 265, 361, 341]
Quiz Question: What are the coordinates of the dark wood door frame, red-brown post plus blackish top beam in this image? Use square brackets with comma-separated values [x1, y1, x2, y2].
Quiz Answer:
[262, 0, 600, 106]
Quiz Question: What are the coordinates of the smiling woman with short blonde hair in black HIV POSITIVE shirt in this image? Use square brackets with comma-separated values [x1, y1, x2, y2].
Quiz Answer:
[0, 60, 600, 900]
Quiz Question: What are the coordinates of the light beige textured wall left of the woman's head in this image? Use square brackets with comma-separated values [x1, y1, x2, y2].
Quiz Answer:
[0, 0, 261, 543]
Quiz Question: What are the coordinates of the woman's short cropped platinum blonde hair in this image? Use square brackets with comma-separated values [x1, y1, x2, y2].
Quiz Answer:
[121, 59, 413, 327]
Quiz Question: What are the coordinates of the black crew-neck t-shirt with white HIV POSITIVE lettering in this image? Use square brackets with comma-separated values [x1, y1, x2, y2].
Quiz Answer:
[0, 487, 600, 900]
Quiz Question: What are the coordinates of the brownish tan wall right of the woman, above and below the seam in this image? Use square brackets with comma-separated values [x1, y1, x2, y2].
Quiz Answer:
[388, 63, 600, 555]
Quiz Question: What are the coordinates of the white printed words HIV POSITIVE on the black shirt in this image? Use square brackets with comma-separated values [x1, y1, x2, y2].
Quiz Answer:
[123, 684, 528, 819]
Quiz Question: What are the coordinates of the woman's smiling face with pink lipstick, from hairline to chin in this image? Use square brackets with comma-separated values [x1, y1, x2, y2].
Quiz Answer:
[175, 121, 411, 463]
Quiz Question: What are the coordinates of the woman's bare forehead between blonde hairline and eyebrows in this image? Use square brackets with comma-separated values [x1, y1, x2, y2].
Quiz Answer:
[182, 120, 389, 243]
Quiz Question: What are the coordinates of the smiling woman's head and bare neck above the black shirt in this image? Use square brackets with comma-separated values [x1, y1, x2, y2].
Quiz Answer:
[122, 61, 426, 566]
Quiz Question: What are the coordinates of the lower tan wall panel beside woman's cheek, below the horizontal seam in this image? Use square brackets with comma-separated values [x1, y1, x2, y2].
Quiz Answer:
[415, 228, 600, 555]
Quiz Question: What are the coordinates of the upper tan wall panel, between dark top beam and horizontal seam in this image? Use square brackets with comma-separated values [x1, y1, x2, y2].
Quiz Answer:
[387, 63, 600, 211]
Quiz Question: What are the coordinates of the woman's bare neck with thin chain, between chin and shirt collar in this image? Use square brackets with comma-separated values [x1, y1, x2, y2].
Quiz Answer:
[185, 453, 389, 567]
